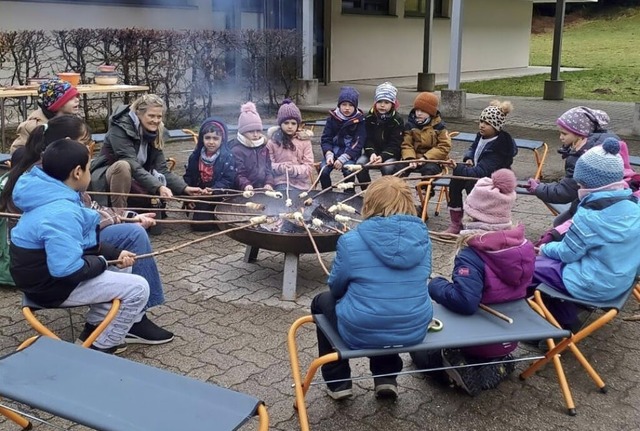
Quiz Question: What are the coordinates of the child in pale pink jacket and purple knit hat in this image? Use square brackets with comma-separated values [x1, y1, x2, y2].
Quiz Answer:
[267, 99, 313, 192]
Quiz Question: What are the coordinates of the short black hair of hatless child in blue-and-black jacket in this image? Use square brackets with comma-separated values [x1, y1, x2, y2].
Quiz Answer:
[42, 138, 89, 181]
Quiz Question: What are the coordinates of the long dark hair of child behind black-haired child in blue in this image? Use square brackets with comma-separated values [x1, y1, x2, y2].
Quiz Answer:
[0, 115, 90, 211]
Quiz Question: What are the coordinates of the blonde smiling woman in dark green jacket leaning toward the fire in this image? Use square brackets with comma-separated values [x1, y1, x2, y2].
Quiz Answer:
[90, 94, 204, 208]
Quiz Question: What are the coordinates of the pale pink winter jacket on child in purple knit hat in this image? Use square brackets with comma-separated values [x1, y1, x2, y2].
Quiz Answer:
[267, 127, 314, 190]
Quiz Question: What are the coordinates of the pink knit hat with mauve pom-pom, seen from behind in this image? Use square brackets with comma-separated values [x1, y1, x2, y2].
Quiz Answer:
[464, 169, 516, 224]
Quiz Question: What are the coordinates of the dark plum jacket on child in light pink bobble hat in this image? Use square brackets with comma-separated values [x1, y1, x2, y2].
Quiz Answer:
[230, 138, 274, 190]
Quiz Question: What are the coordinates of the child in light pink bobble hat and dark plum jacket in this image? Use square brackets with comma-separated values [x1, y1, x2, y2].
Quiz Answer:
[230, 102, 273, 190]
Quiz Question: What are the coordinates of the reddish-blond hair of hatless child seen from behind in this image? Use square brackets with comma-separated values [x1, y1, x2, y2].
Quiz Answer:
[362, 176, 416, 219]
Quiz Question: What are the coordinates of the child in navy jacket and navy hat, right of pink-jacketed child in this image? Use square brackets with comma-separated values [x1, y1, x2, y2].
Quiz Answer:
[320, 87, 366, 189]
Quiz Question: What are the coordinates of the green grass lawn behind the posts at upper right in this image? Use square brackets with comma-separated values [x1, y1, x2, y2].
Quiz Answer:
[441, 8, 640, 102]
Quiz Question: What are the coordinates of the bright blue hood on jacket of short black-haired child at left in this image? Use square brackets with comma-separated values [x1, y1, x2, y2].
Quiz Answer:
[13, 166, 80, 212]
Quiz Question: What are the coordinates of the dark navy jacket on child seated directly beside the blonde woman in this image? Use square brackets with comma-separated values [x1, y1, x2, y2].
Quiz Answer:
[182, 117, 236, 189]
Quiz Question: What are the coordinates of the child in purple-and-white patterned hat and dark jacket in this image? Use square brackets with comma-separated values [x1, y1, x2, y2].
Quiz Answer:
[527, 106, 620, 226]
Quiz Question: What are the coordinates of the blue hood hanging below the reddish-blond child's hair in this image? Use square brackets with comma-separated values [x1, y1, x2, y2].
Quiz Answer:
[357, 215, 431, 269]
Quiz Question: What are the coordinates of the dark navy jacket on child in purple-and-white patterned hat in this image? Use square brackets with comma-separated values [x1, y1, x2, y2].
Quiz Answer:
[534, 131, 620, 204]
